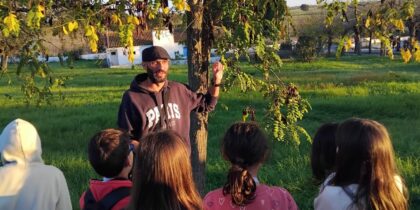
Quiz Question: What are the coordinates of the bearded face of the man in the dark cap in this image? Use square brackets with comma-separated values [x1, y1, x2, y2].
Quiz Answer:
[144, 59, 169, 84]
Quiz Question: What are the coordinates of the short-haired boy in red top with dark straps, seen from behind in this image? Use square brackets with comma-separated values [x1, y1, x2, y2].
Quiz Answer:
[79, 129, 134, 210]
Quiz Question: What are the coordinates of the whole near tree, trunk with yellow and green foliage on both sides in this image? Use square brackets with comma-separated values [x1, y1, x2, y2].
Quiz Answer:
[0, 0, 310, 193]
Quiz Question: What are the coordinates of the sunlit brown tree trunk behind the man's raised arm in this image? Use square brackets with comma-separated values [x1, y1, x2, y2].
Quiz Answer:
[187, 0, 211, 195]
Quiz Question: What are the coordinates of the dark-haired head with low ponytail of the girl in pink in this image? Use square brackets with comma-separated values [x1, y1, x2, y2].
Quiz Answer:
[221, 122, 268, 205]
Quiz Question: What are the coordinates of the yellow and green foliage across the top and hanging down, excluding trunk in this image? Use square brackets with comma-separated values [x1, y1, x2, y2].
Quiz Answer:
[0, 0, 309, 142]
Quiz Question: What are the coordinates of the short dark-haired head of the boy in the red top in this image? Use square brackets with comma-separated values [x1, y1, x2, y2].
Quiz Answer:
[88, 129, 132, 178]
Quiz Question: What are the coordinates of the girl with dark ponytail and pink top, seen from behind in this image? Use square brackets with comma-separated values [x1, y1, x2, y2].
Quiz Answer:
[204, 123, 297, 210]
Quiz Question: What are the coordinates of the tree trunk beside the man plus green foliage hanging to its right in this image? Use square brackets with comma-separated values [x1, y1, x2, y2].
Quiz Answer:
[187, 0, 309, 193]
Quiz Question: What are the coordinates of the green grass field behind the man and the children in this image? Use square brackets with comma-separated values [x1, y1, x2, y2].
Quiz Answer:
[0, 56, 420, 209]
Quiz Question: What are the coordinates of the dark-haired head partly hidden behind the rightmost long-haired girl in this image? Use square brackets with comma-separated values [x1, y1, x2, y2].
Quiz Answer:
[311, 123, 338, 181]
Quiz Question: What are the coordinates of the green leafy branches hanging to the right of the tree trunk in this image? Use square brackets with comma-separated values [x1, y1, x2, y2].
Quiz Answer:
[209, 0, 310, 144]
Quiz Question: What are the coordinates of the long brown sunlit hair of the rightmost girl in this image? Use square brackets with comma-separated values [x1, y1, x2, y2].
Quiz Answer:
[333, 118, 408, 210]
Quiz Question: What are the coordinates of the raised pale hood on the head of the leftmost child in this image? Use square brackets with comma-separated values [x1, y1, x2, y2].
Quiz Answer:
[0, 119, 43, 164]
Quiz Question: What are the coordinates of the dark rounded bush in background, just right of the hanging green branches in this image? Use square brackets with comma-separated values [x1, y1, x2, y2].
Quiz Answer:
[294, 36, 317, 62]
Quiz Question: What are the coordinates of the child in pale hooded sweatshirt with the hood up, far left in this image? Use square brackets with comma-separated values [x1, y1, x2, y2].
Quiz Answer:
[0, 119, 72, 210]
